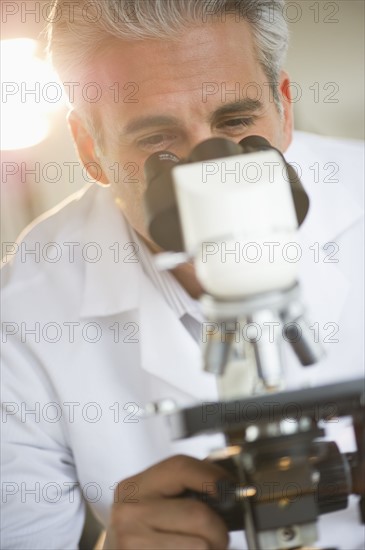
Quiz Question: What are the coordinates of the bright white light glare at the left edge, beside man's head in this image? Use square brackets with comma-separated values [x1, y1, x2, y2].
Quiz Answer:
[0, 38, 65, 150]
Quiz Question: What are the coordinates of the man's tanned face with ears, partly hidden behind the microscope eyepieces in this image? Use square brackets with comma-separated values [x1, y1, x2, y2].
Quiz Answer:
[71, 20, 292, 250]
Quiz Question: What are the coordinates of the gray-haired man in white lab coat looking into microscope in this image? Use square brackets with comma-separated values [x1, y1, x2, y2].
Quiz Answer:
[3, 0, 361, 549]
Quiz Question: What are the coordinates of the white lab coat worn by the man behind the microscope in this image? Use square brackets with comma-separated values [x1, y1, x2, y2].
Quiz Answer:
[1, 134, 364, 550]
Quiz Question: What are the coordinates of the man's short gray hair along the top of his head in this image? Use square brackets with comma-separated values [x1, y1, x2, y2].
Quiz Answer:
[48, 0, 288, 129]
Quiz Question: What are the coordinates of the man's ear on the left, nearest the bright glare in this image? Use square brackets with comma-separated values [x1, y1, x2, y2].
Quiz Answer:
[67, 111, 109, 185]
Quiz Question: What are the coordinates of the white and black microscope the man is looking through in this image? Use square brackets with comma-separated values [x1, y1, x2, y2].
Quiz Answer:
[145, 136, 365, 550]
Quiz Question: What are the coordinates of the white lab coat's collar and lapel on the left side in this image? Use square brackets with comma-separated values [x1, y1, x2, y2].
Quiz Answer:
[74, 188, 216, 399]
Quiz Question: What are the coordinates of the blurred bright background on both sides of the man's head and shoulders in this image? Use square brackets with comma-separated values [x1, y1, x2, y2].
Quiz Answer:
[0, 0, 365, 250]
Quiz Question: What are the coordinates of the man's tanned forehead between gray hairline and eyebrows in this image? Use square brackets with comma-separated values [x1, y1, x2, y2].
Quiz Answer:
[77, 20, 264, 135]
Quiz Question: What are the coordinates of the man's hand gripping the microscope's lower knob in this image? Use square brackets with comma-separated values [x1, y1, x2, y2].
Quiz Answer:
[104, 455, 229, 550]
